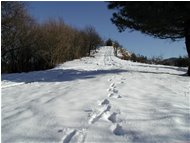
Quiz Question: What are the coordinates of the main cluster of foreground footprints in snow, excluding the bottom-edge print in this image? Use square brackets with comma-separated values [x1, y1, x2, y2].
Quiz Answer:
[88, 75, 125, 136]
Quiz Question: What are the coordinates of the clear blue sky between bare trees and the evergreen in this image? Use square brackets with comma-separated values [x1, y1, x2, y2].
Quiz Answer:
[28, 1, 187, 58]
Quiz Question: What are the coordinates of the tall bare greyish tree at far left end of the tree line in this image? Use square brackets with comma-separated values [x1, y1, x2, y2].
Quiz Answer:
[1, 1, 33, 72]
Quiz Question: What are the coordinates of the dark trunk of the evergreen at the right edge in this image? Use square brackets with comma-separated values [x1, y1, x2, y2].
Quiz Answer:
[185, 20, 190, 76]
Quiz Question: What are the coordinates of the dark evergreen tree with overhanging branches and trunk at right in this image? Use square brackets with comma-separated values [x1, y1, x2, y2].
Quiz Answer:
[108, 1, 190, 76]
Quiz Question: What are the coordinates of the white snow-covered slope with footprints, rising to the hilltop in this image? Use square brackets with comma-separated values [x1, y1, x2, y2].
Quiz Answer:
[1, 47, 190, 143]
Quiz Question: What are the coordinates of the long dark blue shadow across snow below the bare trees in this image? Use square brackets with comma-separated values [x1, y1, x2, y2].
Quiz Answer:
[1, 69, 127, 83]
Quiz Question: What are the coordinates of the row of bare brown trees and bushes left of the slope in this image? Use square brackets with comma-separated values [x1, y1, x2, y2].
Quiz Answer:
[1, 1, 103, 73]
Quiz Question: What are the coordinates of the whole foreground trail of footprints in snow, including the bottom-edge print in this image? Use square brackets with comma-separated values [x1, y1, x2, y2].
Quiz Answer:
[58, 76, 125, 143]
